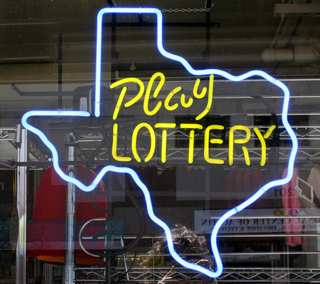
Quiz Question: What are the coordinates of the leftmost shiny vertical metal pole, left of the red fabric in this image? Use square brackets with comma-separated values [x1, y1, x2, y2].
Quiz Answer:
[16, 127, 28, 284]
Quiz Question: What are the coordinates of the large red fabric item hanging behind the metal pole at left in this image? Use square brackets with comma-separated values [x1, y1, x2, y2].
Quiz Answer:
[27, 166, 107, 264]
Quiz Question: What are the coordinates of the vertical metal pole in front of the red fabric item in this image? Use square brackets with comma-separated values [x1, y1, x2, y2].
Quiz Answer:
[64, 134, 75, 284]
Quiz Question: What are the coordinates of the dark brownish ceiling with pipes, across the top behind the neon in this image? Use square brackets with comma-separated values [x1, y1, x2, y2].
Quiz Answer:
[0, 0, 320, 83]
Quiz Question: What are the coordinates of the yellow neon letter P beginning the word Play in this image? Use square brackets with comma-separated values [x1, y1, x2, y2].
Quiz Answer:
[110, 78, 144, 120]
